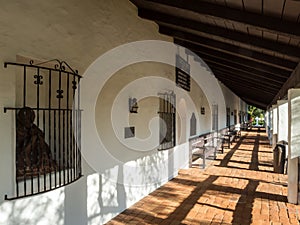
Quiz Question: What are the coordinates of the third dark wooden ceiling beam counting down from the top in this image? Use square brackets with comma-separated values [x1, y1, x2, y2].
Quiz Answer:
[159, 25, 297, 72]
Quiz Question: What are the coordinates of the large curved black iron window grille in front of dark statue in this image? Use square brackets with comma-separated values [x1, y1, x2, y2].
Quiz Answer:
[4, 59, 82, 200]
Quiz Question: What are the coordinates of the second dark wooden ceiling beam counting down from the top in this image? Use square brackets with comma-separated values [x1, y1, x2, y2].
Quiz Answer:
[138, 8, 300, 57]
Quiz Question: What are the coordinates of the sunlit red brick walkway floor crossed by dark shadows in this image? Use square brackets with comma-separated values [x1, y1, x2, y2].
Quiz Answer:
[107, 129, 300, 225]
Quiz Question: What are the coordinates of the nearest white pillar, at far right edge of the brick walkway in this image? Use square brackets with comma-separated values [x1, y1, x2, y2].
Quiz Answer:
[288, 89, 300, 204]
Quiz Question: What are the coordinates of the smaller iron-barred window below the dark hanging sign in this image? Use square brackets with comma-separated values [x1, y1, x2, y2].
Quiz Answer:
[158, 91, 176, 150]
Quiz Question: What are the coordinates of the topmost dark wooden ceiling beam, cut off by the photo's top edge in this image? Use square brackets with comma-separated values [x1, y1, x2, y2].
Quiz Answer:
[144, 0, 300, 36]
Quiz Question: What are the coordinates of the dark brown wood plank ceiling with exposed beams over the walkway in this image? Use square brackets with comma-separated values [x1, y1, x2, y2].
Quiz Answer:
[130, 0, 300, 109]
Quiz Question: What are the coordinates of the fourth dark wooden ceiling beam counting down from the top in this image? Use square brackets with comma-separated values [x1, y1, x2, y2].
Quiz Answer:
[174, 39, 291, 77]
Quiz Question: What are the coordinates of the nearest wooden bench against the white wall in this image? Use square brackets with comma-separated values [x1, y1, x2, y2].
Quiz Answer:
[192, 136, 217, 169]
